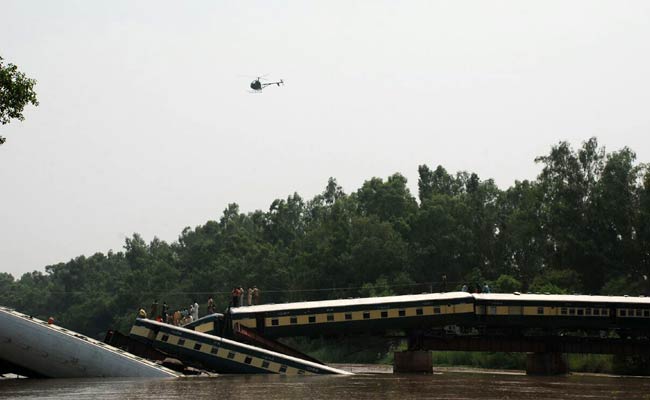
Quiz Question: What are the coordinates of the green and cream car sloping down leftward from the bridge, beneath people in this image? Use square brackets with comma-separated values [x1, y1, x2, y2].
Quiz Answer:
[228, 292, 474, 338]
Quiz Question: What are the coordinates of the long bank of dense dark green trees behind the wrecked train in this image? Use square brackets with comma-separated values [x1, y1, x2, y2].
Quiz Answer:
[0, 139, 650, 336]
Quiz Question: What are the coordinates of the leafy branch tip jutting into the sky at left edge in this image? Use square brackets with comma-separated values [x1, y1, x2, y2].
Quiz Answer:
[0, 57, 38, 145]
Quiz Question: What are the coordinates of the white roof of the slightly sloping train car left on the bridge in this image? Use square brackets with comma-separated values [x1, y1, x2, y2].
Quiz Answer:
[230, 292, 474, 315]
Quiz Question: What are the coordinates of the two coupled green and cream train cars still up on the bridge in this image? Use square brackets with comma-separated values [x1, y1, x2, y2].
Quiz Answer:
[224, 292, 650, 337]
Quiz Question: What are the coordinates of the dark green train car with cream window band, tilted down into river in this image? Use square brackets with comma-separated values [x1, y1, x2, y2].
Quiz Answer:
[130, 319, 350, 375]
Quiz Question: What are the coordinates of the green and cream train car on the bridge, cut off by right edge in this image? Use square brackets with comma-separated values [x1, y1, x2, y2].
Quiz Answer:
[473, 293, 650, 331]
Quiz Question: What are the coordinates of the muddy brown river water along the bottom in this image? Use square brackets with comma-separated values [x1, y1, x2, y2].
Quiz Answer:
[0, 365, 650, 400]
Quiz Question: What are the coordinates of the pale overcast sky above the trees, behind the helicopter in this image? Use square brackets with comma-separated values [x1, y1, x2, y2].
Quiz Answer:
[0, 0, 650, 277]
